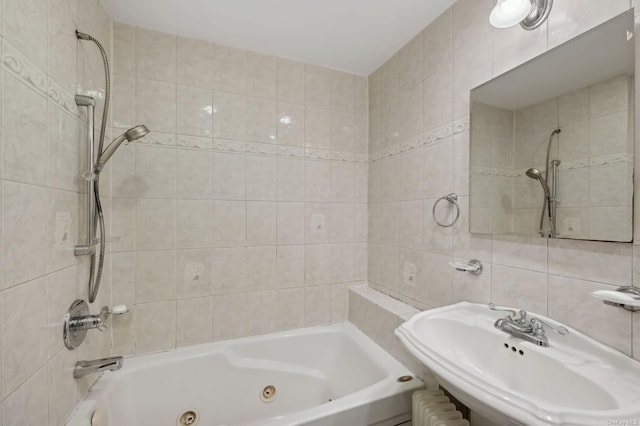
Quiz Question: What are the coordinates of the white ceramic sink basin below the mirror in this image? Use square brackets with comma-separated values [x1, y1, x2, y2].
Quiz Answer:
[396, 302, 640, 426]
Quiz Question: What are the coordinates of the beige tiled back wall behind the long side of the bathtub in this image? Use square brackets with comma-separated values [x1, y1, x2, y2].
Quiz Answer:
[110, 24, 368, 355]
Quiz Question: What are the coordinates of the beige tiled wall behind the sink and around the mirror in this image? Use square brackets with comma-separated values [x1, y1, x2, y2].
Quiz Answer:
[368, 0, 640, 359]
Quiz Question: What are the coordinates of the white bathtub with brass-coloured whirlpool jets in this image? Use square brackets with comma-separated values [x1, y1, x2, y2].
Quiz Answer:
[67, 323, 422, 426]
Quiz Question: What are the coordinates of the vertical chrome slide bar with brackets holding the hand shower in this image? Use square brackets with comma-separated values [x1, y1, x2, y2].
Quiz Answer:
[73, 95, 96, 256]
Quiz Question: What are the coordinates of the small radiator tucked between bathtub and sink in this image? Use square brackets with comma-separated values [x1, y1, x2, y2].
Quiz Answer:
[412, 389, 469, 426]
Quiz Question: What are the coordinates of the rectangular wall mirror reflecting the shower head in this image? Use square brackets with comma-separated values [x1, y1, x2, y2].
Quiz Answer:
[469, 9, 635, 241]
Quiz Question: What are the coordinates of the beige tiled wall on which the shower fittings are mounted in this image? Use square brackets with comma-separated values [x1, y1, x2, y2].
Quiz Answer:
[0, 0, 112, 426]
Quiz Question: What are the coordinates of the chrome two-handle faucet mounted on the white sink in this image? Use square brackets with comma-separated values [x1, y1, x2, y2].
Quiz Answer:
[489, 303, 569, 347]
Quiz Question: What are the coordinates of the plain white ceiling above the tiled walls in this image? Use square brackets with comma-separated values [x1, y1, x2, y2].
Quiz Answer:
[102, 0, 455, 75]
